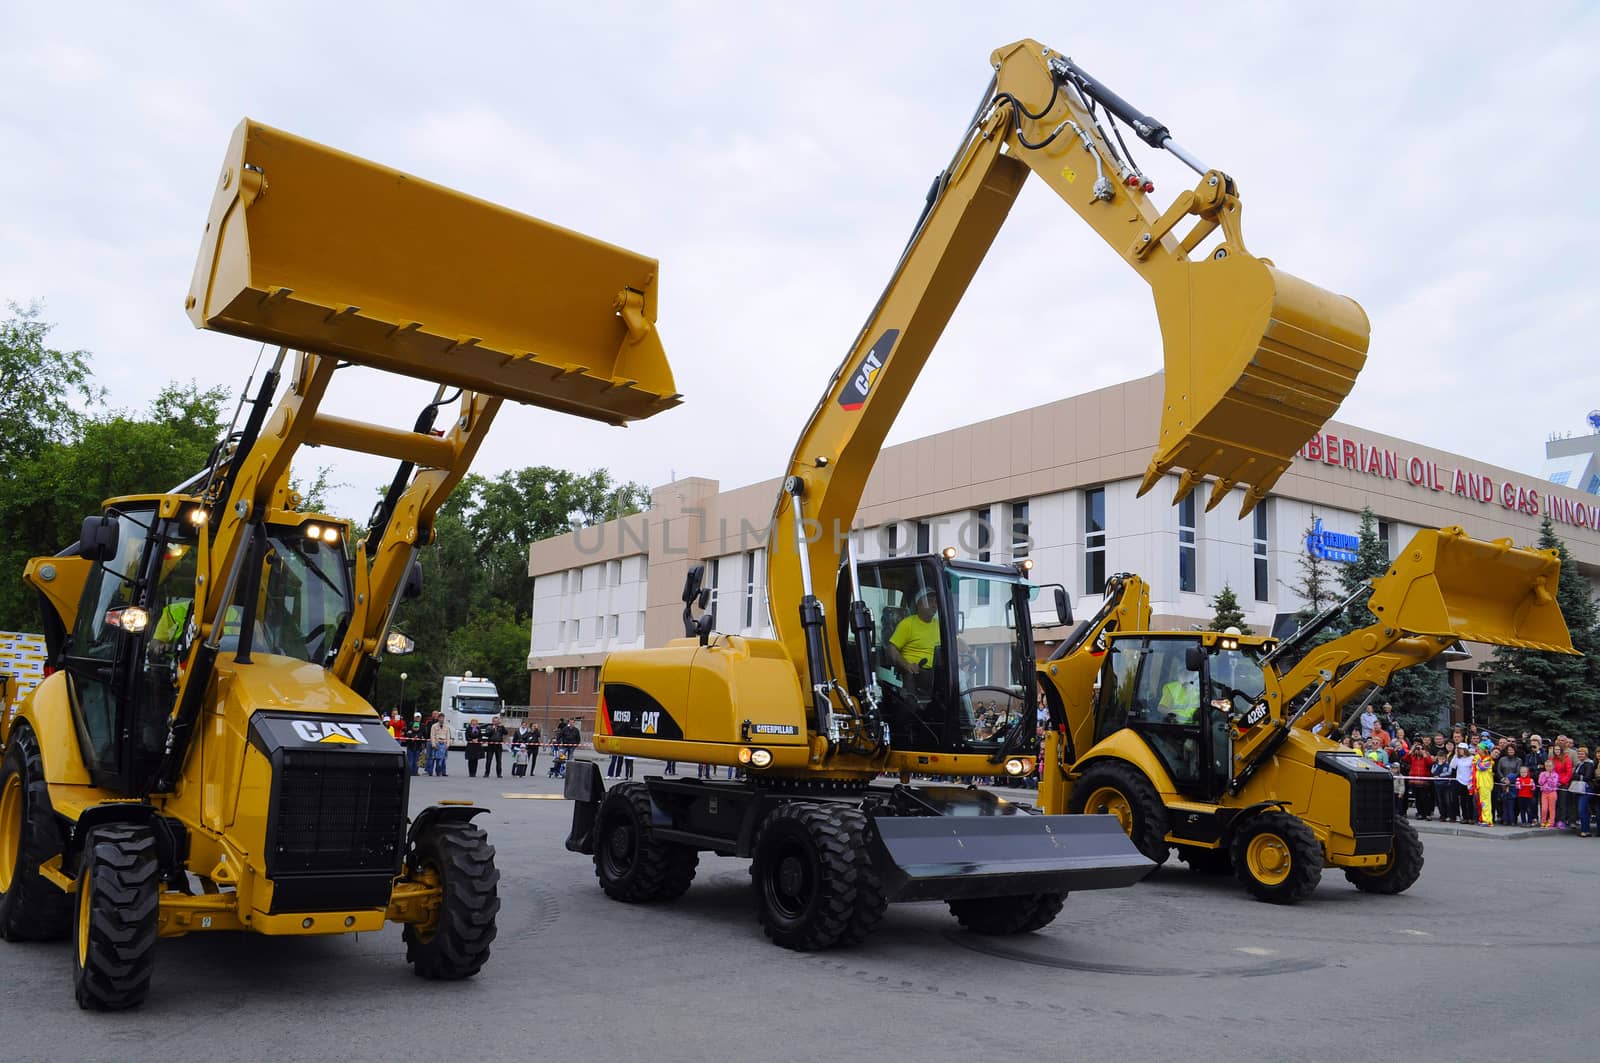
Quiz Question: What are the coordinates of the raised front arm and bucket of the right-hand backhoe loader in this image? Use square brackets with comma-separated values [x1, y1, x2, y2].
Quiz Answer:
[1234, 527, 1576, 786]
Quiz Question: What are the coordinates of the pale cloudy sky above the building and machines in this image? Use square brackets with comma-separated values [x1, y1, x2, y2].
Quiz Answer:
[0, 0, 1600, 517]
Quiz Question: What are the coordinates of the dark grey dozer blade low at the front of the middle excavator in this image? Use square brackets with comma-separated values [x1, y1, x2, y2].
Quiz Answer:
[872, 786, 1155, 901]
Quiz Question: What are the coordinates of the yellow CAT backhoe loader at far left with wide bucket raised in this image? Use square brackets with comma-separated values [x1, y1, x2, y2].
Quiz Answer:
[0, 120, 678, 1009]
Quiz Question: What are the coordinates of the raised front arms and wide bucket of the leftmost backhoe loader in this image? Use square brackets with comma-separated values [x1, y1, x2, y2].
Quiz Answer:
[142, 120, 680, 789]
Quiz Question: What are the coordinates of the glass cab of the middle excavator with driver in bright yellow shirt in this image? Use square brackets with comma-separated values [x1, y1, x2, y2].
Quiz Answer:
[837, 554, 1062, 756]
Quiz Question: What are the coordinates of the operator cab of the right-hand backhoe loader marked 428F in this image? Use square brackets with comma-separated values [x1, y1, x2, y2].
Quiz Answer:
[1094, 631, 1269, 800]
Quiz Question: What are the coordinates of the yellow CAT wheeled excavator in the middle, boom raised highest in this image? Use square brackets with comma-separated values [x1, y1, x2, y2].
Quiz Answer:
[566, 40, 1368, 949]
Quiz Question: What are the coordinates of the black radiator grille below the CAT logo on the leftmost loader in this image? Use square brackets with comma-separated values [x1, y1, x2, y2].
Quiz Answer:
[267, 751, 405, 876]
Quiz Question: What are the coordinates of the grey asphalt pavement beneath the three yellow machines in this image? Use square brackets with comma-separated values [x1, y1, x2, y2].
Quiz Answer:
[0, 756, 1600, 1063]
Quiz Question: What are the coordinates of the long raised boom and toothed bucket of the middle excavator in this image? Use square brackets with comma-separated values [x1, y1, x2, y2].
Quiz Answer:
[766, 40, 1368, 752]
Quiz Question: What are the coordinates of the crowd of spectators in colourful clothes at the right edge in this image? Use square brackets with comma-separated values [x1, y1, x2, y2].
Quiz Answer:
[1338, 704, 1595, 837]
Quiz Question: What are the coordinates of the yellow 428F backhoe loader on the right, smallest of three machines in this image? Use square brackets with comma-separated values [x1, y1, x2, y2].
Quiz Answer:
[1038, 527, 1573, 905]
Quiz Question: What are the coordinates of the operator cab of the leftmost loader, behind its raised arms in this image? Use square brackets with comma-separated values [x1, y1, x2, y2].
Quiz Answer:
[60, 495, 352, 792]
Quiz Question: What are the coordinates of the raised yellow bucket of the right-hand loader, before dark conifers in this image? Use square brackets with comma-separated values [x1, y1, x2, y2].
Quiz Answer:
[1366, 527, 1581, 653]
